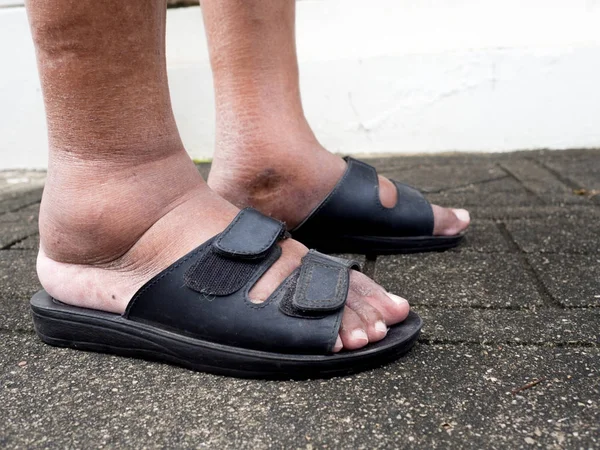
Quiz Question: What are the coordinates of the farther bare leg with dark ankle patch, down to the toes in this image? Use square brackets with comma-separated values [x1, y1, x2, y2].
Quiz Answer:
[202, 0, 469, 235]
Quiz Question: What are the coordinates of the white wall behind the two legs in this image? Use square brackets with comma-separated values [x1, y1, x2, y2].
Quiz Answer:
[0, 0, 600, 168]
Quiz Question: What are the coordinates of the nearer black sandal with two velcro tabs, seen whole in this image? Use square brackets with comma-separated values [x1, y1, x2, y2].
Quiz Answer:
[31, 209, 421, 378]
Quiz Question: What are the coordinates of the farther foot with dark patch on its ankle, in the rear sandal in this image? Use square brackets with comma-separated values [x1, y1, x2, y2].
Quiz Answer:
[208, 134, 471, 236]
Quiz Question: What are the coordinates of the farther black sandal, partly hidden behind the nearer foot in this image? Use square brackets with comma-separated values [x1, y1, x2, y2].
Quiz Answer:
[291, 157, 464, 254]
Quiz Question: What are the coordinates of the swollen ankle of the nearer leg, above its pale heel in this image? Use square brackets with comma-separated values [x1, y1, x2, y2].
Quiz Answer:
[40, 149, 208, 265]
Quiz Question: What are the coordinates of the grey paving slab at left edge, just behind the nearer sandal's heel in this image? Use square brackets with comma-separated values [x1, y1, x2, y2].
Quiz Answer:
[0, 250, 40, 330]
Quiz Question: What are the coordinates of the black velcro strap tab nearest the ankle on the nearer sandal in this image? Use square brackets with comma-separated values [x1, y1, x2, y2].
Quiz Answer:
[213, 208, 285, 259]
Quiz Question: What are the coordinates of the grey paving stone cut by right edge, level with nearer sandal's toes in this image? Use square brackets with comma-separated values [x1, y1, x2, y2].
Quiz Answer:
[527, 254, 600, 307]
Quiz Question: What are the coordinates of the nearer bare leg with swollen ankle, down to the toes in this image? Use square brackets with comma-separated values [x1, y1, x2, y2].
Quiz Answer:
[27, 0, 408, 349]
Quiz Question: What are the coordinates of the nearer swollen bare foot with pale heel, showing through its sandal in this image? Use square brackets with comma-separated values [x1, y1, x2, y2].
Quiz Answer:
[37, 151, 409, 351]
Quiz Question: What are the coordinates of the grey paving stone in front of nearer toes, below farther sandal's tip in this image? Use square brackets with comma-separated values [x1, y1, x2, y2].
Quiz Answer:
[375, 252, 543, 308]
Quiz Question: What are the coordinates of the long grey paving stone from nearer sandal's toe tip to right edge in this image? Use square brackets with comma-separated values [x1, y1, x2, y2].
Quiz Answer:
[413, 306, 600, 345]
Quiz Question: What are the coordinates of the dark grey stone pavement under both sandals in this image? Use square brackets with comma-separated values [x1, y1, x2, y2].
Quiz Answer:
[0, 150, 600, 449]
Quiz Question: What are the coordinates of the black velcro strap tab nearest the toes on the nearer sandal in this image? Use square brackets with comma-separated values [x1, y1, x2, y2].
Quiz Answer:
[292, 250, 357, 314]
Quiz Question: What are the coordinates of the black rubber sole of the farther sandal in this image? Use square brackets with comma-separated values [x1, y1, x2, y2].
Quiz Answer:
[292, 234, 464, 255]
